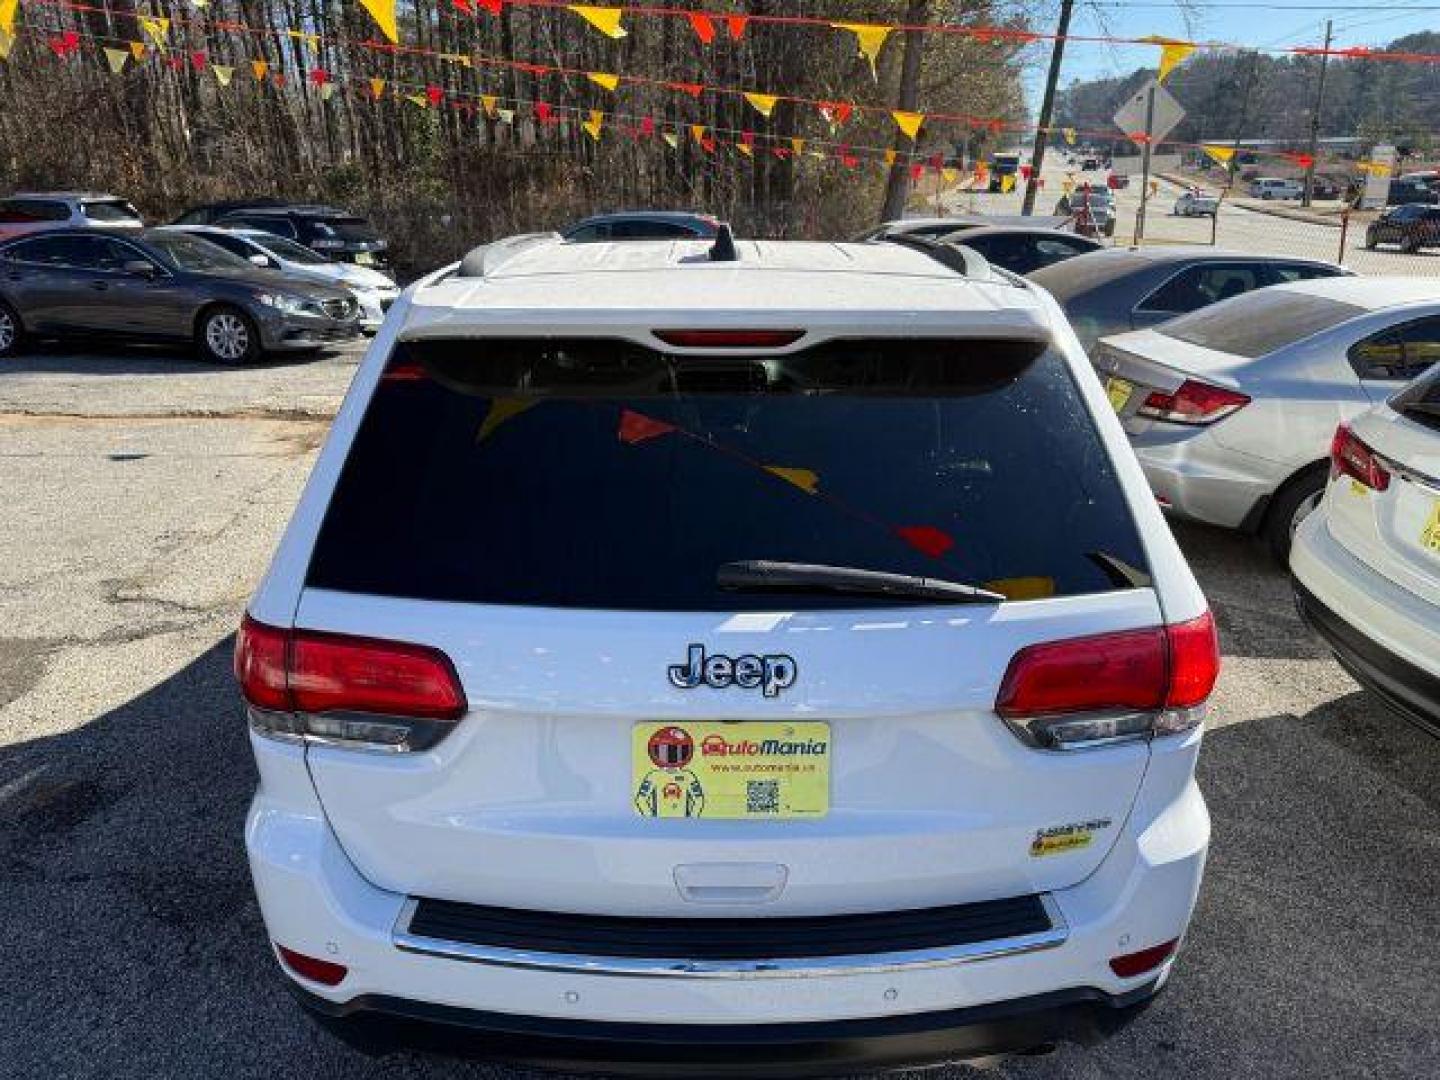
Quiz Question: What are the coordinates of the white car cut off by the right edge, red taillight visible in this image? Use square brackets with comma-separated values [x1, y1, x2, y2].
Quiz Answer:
[1290, 373, 1440, 733]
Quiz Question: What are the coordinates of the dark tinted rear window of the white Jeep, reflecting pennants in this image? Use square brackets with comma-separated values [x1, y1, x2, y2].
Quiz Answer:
[308, 338, 1148, 611]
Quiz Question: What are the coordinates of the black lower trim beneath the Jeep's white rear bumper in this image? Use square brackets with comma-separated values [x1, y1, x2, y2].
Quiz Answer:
[291, 981, 1159, 1077]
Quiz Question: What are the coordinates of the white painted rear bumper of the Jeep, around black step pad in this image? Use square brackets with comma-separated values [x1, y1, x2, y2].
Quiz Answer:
[246, 732, 1210, 1061]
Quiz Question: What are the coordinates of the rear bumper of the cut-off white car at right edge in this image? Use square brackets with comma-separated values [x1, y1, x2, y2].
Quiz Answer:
[1290, 514, 1440, 730]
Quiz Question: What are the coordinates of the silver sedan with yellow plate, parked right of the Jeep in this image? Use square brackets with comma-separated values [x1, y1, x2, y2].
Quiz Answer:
[1093, 278, 1440, 562]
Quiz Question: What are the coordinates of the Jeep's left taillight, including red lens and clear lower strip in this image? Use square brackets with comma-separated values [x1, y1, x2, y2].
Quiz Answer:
[235, 616, 467, 750]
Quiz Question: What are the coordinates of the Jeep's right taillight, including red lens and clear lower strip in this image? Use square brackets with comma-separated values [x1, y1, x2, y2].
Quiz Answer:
[995, 611, 1220, 749]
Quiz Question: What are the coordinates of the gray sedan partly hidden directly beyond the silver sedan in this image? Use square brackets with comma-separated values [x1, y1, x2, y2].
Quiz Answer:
[1027, 248, 1349, 350]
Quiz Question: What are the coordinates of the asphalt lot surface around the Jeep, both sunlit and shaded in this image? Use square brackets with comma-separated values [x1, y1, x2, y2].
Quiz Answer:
[0, 350, 1440, 1080]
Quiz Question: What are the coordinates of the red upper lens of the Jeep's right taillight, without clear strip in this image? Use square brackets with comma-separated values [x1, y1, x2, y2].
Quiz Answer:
[995, 611, 1220, 719]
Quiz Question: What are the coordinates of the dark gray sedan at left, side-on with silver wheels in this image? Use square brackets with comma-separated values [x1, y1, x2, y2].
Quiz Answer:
[0, 229, 360, 364]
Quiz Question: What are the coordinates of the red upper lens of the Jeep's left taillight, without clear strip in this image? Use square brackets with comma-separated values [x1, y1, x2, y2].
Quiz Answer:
[235, 616, 465, 720]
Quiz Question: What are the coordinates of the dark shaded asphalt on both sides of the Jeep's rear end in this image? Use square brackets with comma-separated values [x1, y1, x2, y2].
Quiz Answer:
[0, 639, 1440, 1080]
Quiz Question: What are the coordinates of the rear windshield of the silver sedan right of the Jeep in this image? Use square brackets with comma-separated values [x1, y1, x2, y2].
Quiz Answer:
[1158, 289, 1365, 359]
